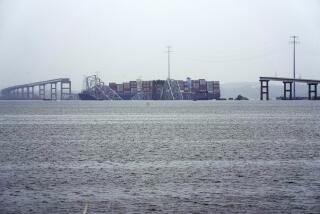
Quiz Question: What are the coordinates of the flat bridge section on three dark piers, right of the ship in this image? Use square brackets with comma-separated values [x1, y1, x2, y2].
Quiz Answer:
[260, 77, 320, 100]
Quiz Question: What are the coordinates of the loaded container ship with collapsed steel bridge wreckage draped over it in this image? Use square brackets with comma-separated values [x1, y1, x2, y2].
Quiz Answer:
[79, 75, 220, 100]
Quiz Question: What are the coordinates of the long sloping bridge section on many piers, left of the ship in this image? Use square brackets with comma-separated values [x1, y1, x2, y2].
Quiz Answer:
[1, 78, 71, 100]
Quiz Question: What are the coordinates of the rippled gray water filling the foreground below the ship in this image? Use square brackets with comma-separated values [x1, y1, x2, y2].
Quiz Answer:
[0, 101, 320, 213]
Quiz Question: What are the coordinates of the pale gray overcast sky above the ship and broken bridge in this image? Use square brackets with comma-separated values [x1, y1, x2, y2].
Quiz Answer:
[0, 0, 320, 90]
